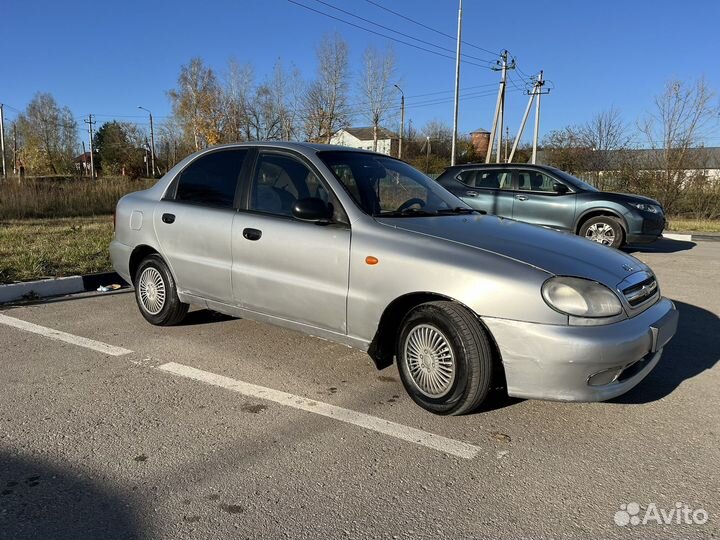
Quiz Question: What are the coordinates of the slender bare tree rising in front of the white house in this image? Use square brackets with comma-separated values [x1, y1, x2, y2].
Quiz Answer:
[362, 45, 395, 151]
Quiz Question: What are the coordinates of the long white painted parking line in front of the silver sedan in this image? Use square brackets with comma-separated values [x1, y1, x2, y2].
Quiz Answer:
[158, 362, 480, 459]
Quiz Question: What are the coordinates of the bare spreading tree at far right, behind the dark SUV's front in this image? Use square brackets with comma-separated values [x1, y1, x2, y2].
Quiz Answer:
[640, 79, 720, 213]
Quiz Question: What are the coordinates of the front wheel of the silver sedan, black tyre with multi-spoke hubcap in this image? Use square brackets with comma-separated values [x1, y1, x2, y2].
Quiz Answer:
[397, 301, 493, 415]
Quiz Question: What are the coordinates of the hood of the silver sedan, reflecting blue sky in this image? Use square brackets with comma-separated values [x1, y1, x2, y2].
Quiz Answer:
[377, 215, 649, 287]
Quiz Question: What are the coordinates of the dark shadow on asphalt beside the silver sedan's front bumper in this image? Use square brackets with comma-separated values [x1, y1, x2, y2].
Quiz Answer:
[610, 302, 720, 404]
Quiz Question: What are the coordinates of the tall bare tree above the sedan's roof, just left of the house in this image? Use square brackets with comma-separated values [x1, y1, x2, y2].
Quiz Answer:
[303, 33, 350, 143]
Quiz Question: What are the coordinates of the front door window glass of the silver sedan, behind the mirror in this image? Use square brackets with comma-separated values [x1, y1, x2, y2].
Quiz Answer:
[250, 154, 346, 222]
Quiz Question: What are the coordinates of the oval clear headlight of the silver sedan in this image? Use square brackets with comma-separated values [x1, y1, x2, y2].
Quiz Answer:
[542, 276, 623, 318]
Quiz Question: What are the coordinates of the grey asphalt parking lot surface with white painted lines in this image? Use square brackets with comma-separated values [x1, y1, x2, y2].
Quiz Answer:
[0, 241, 720, 539]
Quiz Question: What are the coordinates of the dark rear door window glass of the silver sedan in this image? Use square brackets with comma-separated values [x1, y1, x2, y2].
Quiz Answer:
[175, 150, 247, 208]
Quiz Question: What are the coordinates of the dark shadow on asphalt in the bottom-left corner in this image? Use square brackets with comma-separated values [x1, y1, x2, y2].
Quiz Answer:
[0, 450, 146, 540]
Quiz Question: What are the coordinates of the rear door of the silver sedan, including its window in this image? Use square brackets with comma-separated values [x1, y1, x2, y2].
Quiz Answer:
[153, 148, 248, 303]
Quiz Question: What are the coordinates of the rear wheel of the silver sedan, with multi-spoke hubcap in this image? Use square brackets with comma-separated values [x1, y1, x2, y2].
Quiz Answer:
[135, 254, 190, 326]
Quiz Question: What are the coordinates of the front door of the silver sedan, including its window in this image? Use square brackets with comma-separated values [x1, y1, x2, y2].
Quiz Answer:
[232, 151, 350, 334]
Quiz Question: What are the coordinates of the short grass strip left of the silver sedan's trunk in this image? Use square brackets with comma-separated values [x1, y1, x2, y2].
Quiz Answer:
[0, 216, 113, 283]
